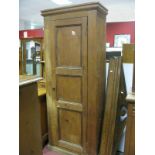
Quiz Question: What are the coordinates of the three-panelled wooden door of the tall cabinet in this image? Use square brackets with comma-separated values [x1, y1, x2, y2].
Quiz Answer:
[47, 17, 87, 154]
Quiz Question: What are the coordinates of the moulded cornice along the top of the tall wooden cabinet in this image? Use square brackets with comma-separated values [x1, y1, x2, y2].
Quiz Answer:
[41, 2, 108, 16]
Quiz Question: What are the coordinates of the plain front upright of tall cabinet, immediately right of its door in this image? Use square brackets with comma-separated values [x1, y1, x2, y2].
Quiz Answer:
[87, 11, 97, 155]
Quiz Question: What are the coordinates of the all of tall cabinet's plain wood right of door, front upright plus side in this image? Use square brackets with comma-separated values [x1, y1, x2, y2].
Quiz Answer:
[87, 10, 106, 155]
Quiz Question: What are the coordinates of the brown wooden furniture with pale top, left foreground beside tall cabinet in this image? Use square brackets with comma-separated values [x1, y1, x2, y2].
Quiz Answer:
[19, 76, 42, 155]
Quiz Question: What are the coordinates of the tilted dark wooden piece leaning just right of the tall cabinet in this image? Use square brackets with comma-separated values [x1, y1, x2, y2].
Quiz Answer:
[99, 57, 127, 155]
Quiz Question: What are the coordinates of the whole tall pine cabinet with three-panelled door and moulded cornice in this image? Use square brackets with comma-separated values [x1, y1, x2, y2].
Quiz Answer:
[42, 3, 107, 155]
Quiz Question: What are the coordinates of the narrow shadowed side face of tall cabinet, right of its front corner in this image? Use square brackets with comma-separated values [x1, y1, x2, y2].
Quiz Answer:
[97, 13, 106, 153]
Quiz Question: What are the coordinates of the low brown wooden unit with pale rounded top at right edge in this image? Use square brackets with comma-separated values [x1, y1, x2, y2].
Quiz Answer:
[124, 94, 135, 155]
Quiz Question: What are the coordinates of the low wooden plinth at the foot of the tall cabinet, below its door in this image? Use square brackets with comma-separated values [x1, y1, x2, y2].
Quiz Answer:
[47, 144, 79, 155]
